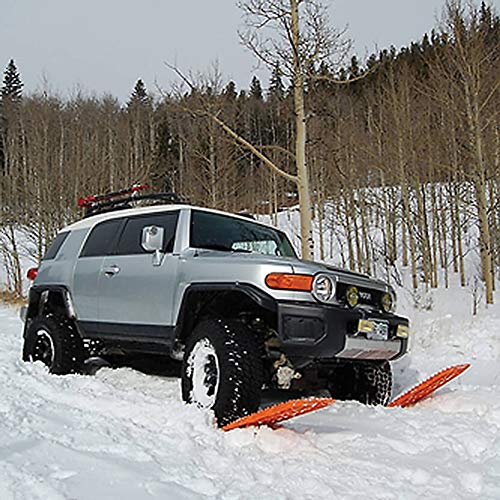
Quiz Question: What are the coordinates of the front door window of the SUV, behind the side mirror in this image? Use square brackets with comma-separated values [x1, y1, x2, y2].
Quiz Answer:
[116, 212, 179, 255]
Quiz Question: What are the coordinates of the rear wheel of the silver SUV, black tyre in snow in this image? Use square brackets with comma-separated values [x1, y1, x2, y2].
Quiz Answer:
[23, 315, 85, 375]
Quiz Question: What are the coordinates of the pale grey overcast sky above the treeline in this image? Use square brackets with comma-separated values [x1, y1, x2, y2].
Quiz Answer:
[0, 0, 500, 101]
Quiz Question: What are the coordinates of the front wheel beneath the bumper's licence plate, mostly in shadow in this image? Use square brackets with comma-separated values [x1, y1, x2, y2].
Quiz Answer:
[328, 361, 392, 405]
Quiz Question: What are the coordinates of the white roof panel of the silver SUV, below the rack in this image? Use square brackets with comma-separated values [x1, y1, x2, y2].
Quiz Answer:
[62, 204, 279, 232]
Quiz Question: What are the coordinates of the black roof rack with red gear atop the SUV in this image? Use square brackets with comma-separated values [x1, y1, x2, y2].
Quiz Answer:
[78, 185, 185, 218]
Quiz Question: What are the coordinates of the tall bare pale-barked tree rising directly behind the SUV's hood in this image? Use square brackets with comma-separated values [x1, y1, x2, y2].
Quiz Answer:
[239, 0, 352, 259]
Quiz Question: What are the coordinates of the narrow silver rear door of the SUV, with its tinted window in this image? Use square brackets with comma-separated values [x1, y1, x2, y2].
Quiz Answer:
[72, 219, 125, 324]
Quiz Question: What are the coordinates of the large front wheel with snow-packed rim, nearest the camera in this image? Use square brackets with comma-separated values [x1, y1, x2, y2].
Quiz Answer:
[181, 319, 264, 426]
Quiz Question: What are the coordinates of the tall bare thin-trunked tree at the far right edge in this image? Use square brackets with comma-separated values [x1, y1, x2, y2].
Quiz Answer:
[426, 0, 500, 304]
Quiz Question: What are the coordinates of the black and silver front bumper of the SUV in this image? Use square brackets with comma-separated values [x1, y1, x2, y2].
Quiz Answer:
[278, 303, 409, 367]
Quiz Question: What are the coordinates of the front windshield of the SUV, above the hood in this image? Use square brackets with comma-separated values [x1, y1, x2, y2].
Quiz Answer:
[190, 210, 296, 257]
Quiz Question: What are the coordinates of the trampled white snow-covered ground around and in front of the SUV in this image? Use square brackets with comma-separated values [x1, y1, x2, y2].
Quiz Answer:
[0, 284, 500, 500]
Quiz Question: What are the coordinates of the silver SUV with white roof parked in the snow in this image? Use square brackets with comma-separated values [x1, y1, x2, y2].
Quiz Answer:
[22, 189, 408, 425]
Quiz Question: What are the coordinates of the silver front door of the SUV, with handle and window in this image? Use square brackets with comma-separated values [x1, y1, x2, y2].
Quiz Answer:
[99, 211, 179, 337]
